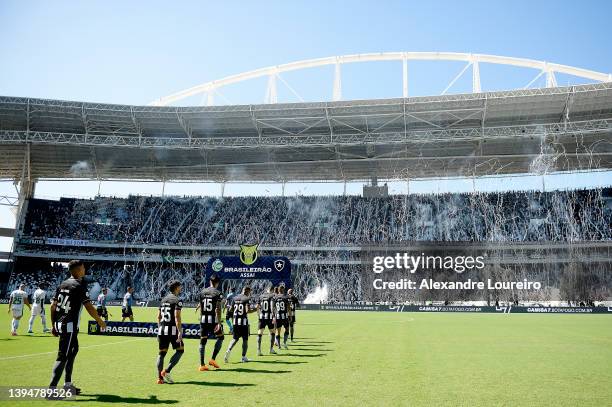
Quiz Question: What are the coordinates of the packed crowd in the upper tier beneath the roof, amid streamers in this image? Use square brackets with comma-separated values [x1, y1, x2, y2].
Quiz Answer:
[24, 189, 612, 246]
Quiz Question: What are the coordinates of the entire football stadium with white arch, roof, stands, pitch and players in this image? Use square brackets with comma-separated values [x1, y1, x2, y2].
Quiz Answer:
[0, 2, 612, 406]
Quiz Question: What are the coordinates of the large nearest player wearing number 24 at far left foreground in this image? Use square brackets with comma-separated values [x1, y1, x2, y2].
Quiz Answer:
[49, 260, 106, 394]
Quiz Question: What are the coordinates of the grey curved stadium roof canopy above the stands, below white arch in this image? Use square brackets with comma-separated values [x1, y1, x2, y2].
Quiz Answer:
[0, 82, 612, 182]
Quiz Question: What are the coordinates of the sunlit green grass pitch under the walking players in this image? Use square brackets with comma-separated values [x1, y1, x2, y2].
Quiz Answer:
[0, 308, 612, 407]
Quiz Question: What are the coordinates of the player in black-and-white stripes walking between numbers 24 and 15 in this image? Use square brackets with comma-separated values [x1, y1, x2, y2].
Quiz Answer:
[157, 281, 185, 384]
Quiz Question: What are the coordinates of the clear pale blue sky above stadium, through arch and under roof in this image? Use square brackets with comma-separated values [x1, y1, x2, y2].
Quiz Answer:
[0, 0, 612, 250]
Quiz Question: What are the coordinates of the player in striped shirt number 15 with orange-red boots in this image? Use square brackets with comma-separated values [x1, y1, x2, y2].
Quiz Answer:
[196, 274, 224, 372]
